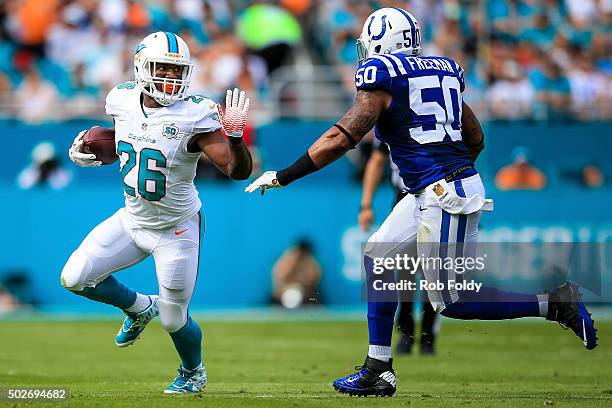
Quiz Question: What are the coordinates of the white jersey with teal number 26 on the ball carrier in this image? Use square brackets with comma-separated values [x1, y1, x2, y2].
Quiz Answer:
[106, 82, 221, 229]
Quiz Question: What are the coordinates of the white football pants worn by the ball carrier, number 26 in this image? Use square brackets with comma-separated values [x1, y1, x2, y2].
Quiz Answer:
[61, 208, 203, 333]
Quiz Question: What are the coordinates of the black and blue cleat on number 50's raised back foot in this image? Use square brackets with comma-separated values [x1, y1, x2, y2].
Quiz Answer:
[546, 282, 597, 350]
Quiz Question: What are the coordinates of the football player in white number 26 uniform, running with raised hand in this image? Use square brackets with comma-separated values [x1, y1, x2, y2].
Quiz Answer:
[61, 32, 252, 393]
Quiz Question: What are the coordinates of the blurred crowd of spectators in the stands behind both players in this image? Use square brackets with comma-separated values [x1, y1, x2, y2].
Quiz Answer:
[0, 0, 612, 123]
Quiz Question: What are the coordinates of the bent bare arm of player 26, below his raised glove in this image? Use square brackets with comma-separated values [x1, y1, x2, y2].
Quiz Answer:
[195, 129, 253, 180]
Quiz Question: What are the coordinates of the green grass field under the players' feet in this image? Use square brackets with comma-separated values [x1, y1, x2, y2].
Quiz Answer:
[0, 319, 612, 407]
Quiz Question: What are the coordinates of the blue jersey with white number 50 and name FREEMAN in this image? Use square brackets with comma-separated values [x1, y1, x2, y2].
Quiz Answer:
[355, 54, 476, 193]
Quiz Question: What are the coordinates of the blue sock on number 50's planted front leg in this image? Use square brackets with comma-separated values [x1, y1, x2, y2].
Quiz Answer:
[363, 256, 397, 346]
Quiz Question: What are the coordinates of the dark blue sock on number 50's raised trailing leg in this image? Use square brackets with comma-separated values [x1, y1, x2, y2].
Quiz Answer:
[441, 286, 540, 320]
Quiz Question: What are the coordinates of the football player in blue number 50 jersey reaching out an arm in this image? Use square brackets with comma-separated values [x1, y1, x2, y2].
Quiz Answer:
[246, 8, 597, 396]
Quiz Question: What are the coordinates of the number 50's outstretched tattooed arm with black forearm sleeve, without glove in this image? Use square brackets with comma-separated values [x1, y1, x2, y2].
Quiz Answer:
[277, 90, 391, 186]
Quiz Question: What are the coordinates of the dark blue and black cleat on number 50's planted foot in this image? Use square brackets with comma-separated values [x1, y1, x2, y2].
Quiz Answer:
[333, 357, 397, 397]
